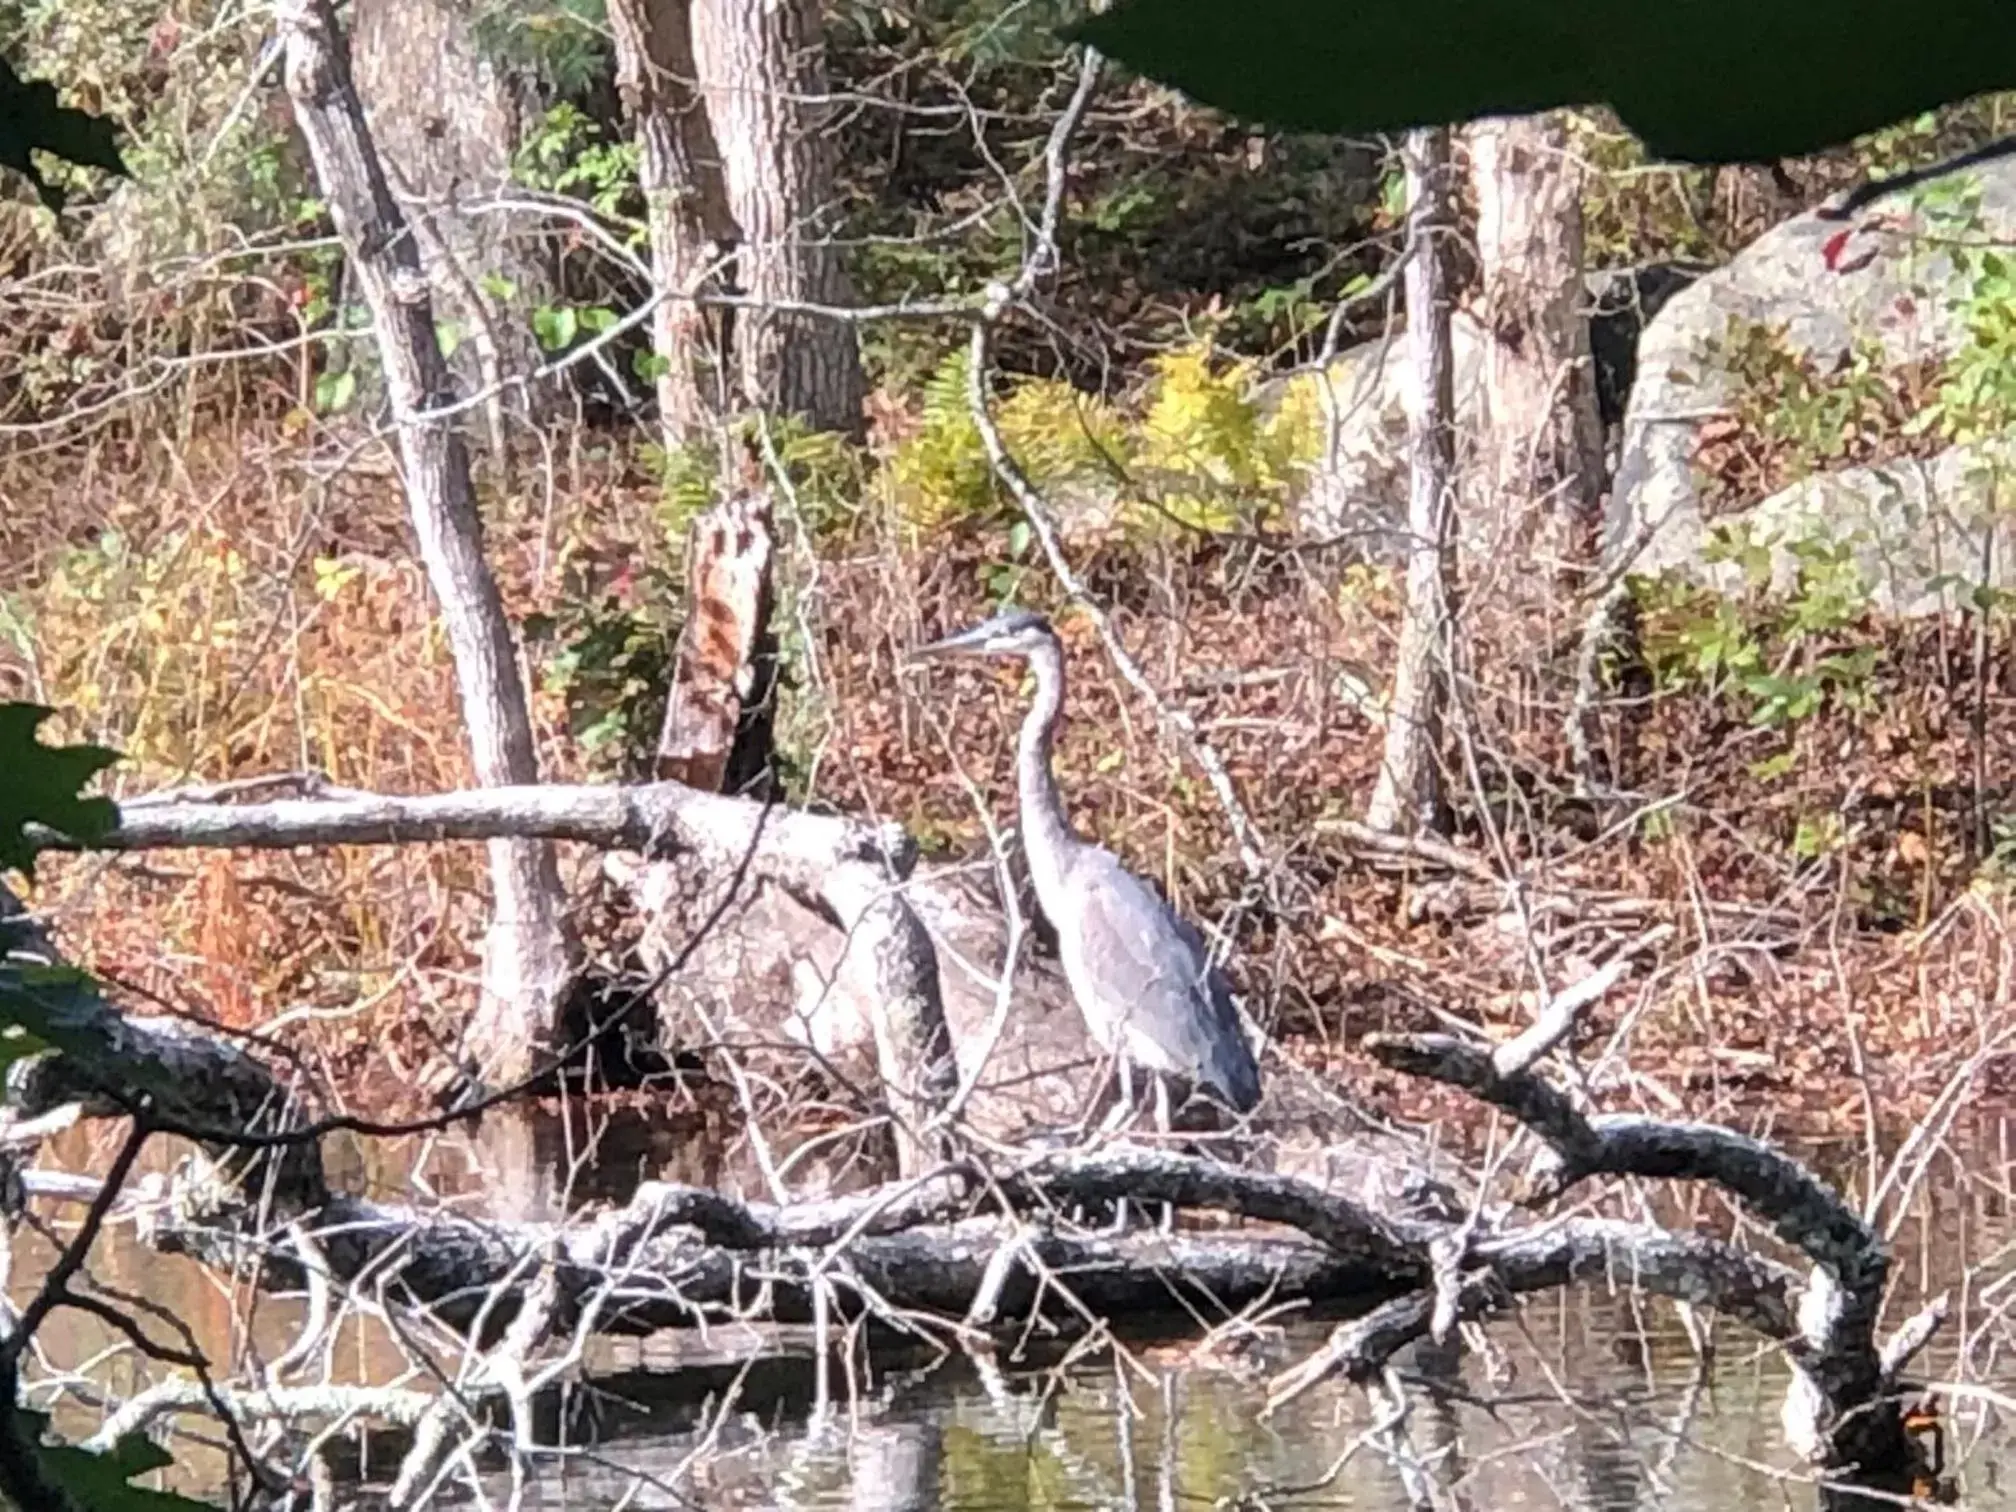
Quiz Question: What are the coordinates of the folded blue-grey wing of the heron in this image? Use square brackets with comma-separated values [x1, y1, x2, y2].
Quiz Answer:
[1070, 849, 1258, 1109]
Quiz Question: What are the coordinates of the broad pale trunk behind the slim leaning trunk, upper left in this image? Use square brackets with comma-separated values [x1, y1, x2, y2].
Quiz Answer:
[351, 0, 552, 449]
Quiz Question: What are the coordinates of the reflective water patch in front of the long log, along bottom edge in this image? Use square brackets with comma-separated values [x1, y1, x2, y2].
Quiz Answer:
[498, 1294, 1804, 1512]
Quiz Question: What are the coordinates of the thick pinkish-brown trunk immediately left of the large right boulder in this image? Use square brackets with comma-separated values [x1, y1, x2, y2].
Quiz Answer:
[1470, 113, 1603, 558]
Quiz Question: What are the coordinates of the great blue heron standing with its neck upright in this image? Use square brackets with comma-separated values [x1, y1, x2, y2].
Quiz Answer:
[917, 609, 1260, 1131]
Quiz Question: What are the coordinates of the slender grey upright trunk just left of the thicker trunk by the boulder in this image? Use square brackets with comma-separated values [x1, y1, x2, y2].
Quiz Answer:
[1365, 127, 1456, 831]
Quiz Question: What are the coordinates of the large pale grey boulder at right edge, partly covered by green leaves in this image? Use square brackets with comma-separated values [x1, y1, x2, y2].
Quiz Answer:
[1605, 163, 2016, 613]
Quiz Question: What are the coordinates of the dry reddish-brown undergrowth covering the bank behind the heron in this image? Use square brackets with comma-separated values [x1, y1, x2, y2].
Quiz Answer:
[0, 385, 2016, 1131]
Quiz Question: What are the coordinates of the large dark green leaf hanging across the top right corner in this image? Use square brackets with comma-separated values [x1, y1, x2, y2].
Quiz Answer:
[1068, 0, 2016, 163]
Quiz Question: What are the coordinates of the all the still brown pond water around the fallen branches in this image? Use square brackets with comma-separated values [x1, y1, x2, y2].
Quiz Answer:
[10, 1115, 2016, 1512]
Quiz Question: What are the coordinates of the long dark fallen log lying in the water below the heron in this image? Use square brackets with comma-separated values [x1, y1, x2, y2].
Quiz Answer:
[117, 1149, 1798, 1370]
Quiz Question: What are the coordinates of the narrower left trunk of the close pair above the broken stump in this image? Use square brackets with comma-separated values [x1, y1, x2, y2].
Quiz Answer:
[609, 0, 736, 448]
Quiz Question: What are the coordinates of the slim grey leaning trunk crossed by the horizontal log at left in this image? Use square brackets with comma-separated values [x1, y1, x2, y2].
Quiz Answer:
[278, 0, 573, 1081]
